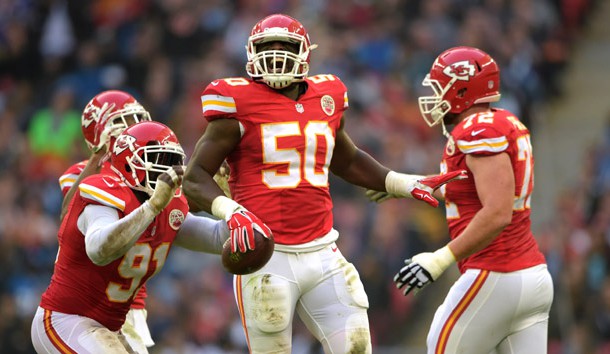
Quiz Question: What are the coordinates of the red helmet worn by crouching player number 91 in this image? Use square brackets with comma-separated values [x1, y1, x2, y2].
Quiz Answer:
[110, 121, 186, 195]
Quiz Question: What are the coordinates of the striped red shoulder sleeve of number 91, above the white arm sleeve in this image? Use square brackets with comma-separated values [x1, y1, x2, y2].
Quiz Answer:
[78, 174, 130, 212]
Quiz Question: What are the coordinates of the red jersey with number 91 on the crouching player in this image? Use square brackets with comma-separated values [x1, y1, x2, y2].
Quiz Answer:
[40, 174, 188, 331]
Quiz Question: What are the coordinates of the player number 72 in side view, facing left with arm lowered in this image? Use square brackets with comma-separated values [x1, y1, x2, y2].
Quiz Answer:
[394, 47, 553, 354]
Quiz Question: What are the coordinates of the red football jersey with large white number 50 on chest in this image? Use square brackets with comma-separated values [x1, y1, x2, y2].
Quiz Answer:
[201, 75, 348, 245]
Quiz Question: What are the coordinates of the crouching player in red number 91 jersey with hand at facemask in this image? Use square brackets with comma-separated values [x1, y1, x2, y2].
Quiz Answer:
[32, 121, 229, 353]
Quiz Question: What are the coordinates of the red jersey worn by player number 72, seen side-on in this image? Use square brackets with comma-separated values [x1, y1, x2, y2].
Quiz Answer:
[441, 109, 545, 272]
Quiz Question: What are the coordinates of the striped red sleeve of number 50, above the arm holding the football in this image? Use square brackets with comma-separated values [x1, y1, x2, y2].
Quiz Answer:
[201, 78, 239, 121]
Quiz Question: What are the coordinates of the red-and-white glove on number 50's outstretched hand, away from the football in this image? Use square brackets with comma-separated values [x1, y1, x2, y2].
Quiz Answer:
[385, 170, 468, 208]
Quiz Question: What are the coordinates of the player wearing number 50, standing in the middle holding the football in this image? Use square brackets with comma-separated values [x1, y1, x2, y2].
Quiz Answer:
[184, 14, 461, 353]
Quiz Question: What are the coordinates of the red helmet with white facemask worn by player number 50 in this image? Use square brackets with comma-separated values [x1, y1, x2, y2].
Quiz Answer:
[246, 14, 317, 89]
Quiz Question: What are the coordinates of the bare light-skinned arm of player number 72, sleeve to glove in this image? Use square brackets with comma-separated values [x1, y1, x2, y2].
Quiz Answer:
[449, 153, 515, 260]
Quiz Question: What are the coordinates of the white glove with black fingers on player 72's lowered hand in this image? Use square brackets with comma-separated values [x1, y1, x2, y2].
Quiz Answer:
[394, 246, 456, 296]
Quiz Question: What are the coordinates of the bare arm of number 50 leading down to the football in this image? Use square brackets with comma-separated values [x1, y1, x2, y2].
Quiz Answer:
[183, 119, 240, 212]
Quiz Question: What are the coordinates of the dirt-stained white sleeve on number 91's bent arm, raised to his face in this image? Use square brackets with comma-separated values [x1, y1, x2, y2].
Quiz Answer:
[78, 201, 156, 266]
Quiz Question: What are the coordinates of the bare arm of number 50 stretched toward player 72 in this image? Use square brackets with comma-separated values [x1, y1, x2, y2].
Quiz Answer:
[330, 119, 390, 191]
